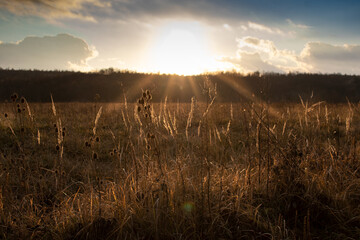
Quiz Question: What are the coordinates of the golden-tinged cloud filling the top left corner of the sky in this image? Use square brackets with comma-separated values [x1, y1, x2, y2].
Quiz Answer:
[0, 0, 111, 22]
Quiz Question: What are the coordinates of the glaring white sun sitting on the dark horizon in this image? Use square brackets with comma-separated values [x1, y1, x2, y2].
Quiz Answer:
[151, 23, 217, 75]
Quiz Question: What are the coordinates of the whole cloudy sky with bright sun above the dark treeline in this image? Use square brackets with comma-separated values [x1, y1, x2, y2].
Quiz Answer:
[0, 0, 360, 75]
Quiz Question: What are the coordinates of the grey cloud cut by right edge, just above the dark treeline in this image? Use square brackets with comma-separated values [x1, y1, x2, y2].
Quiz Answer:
[300, 42, 360, 74]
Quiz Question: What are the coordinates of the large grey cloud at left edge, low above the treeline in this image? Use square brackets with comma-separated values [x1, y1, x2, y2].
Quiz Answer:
[0, 34, 97, 70]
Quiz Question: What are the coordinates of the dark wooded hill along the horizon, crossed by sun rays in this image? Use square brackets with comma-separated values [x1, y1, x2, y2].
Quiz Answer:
[0, 70, 360, 103]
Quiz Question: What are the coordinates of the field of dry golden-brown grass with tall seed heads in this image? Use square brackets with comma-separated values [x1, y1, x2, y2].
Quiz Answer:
[0, 89, 360, 239]
